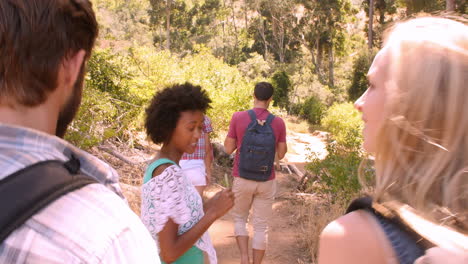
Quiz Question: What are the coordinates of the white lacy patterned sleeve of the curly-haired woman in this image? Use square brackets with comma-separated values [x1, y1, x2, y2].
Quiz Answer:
[141, 165, 191, 236]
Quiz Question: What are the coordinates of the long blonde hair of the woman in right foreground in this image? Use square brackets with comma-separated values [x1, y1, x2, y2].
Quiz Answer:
[375, 17, 468, 231]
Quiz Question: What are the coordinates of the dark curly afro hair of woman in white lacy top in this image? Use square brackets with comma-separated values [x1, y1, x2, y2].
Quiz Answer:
[145, 83, 211, 144]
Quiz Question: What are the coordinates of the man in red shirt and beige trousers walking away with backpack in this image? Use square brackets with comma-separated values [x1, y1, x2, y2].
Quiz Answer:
[224, 82, 287, 264]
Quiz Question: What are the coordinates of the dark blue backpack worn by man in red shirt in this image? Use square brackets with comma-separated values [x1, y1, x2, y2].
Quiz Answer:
[239, 110, 276, 181]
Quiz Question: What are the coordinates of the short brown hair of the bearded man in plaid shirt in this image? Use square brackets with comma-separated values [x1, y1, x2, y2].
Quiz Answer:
[0, 0, 98, 107]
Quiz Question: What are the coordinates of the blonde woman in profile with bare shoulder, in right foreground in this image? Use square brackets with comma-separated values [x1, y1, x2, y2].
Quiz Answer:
[319, 17, 468, 264]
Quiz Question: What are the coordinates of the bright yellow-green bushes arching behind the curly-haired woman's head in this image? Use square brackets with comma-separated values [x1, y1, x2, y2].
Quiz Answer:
[67, 43, 253, 148]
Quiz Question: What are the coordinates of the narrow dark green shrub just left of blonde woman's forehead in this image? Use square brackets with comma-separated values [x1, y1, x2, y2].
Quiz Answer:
[348, 49, 377, 101]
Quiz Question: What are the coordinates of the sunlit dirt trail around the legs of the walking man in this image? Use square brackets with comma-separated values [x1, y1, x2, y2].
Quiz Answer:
[208, 132, 326, 264]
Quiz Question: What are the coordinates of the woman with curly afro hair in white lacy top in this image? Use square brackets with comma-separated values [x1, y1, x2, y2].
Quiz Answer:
[141, 83, 234, 264]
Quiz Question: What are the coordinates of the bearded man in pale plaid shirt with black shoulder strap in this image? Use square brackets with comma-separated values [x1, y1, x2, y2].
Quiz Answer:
[0, 0, 159, 263]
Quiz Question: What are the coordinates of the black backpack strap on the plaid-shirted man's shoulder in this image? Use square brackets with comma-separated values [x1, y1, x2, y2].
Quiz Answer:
[0, 157, 98, 244]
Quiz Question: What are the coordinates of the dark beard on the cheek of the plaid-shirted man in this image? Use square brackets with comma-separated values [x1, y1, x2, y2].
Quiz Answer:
[55, 63, 85, 138]
